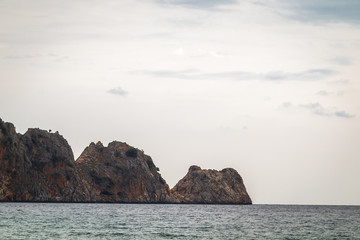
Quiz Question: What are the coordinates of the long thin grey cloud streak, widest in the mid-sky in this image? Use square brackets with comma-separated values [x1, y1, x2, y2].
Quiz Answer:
[135, 69, 336, 81]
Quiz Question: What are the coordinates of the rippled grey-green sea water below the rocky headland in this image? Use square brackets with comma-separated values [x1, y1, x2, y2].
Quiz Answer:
[0, 203, 360, 239]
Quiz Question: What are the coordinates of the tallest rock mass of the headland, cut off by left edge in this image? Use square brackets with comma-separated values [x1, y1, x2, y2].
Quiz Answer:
[0, 119, 89, 202]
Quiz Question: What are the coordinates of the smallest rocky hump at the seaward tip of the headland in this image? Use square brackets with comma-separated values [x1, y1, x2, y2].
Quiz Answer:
[171, 166, 251, 204]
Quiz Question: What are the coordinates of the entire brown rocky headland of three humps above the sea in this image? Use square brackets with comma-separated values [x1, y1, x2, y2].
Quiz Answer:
[0, 119, 252, 204]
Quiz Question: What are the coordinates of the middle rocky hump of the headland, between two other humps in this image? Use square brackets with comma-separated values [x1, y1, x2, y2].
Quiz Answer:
[76, 141, 169, 203]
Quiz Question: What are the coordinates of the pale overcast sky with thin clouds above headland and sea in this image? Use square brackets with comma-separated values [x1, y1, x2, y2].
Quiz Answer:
[0, 0, 360, 205]
